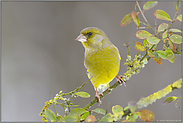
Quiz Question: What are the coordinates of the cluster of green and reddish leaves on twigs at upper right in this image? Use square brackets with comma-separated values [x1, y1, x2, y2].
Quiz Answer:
[121, 1, 182, 64]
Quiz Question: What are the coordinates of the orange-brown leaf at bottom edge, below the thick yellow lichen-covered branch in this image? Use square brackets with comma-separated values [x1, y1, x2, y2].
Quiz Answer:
[136, 109, 154, 122]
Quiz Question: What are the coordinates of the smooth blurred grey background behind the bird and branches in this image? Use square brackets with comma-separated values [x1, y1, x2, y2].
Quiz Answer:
[1, 2, 181, 122]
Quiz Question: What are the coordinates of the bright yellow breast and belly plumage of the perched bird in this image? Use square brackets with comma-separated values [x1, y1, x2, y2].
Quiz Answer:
[85, 47, 120, 89]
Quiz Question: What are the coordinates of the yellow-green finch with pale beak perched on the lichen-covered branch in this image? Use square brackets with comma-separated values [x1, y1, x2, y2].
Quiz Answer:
[76, 27, 125, 103]
